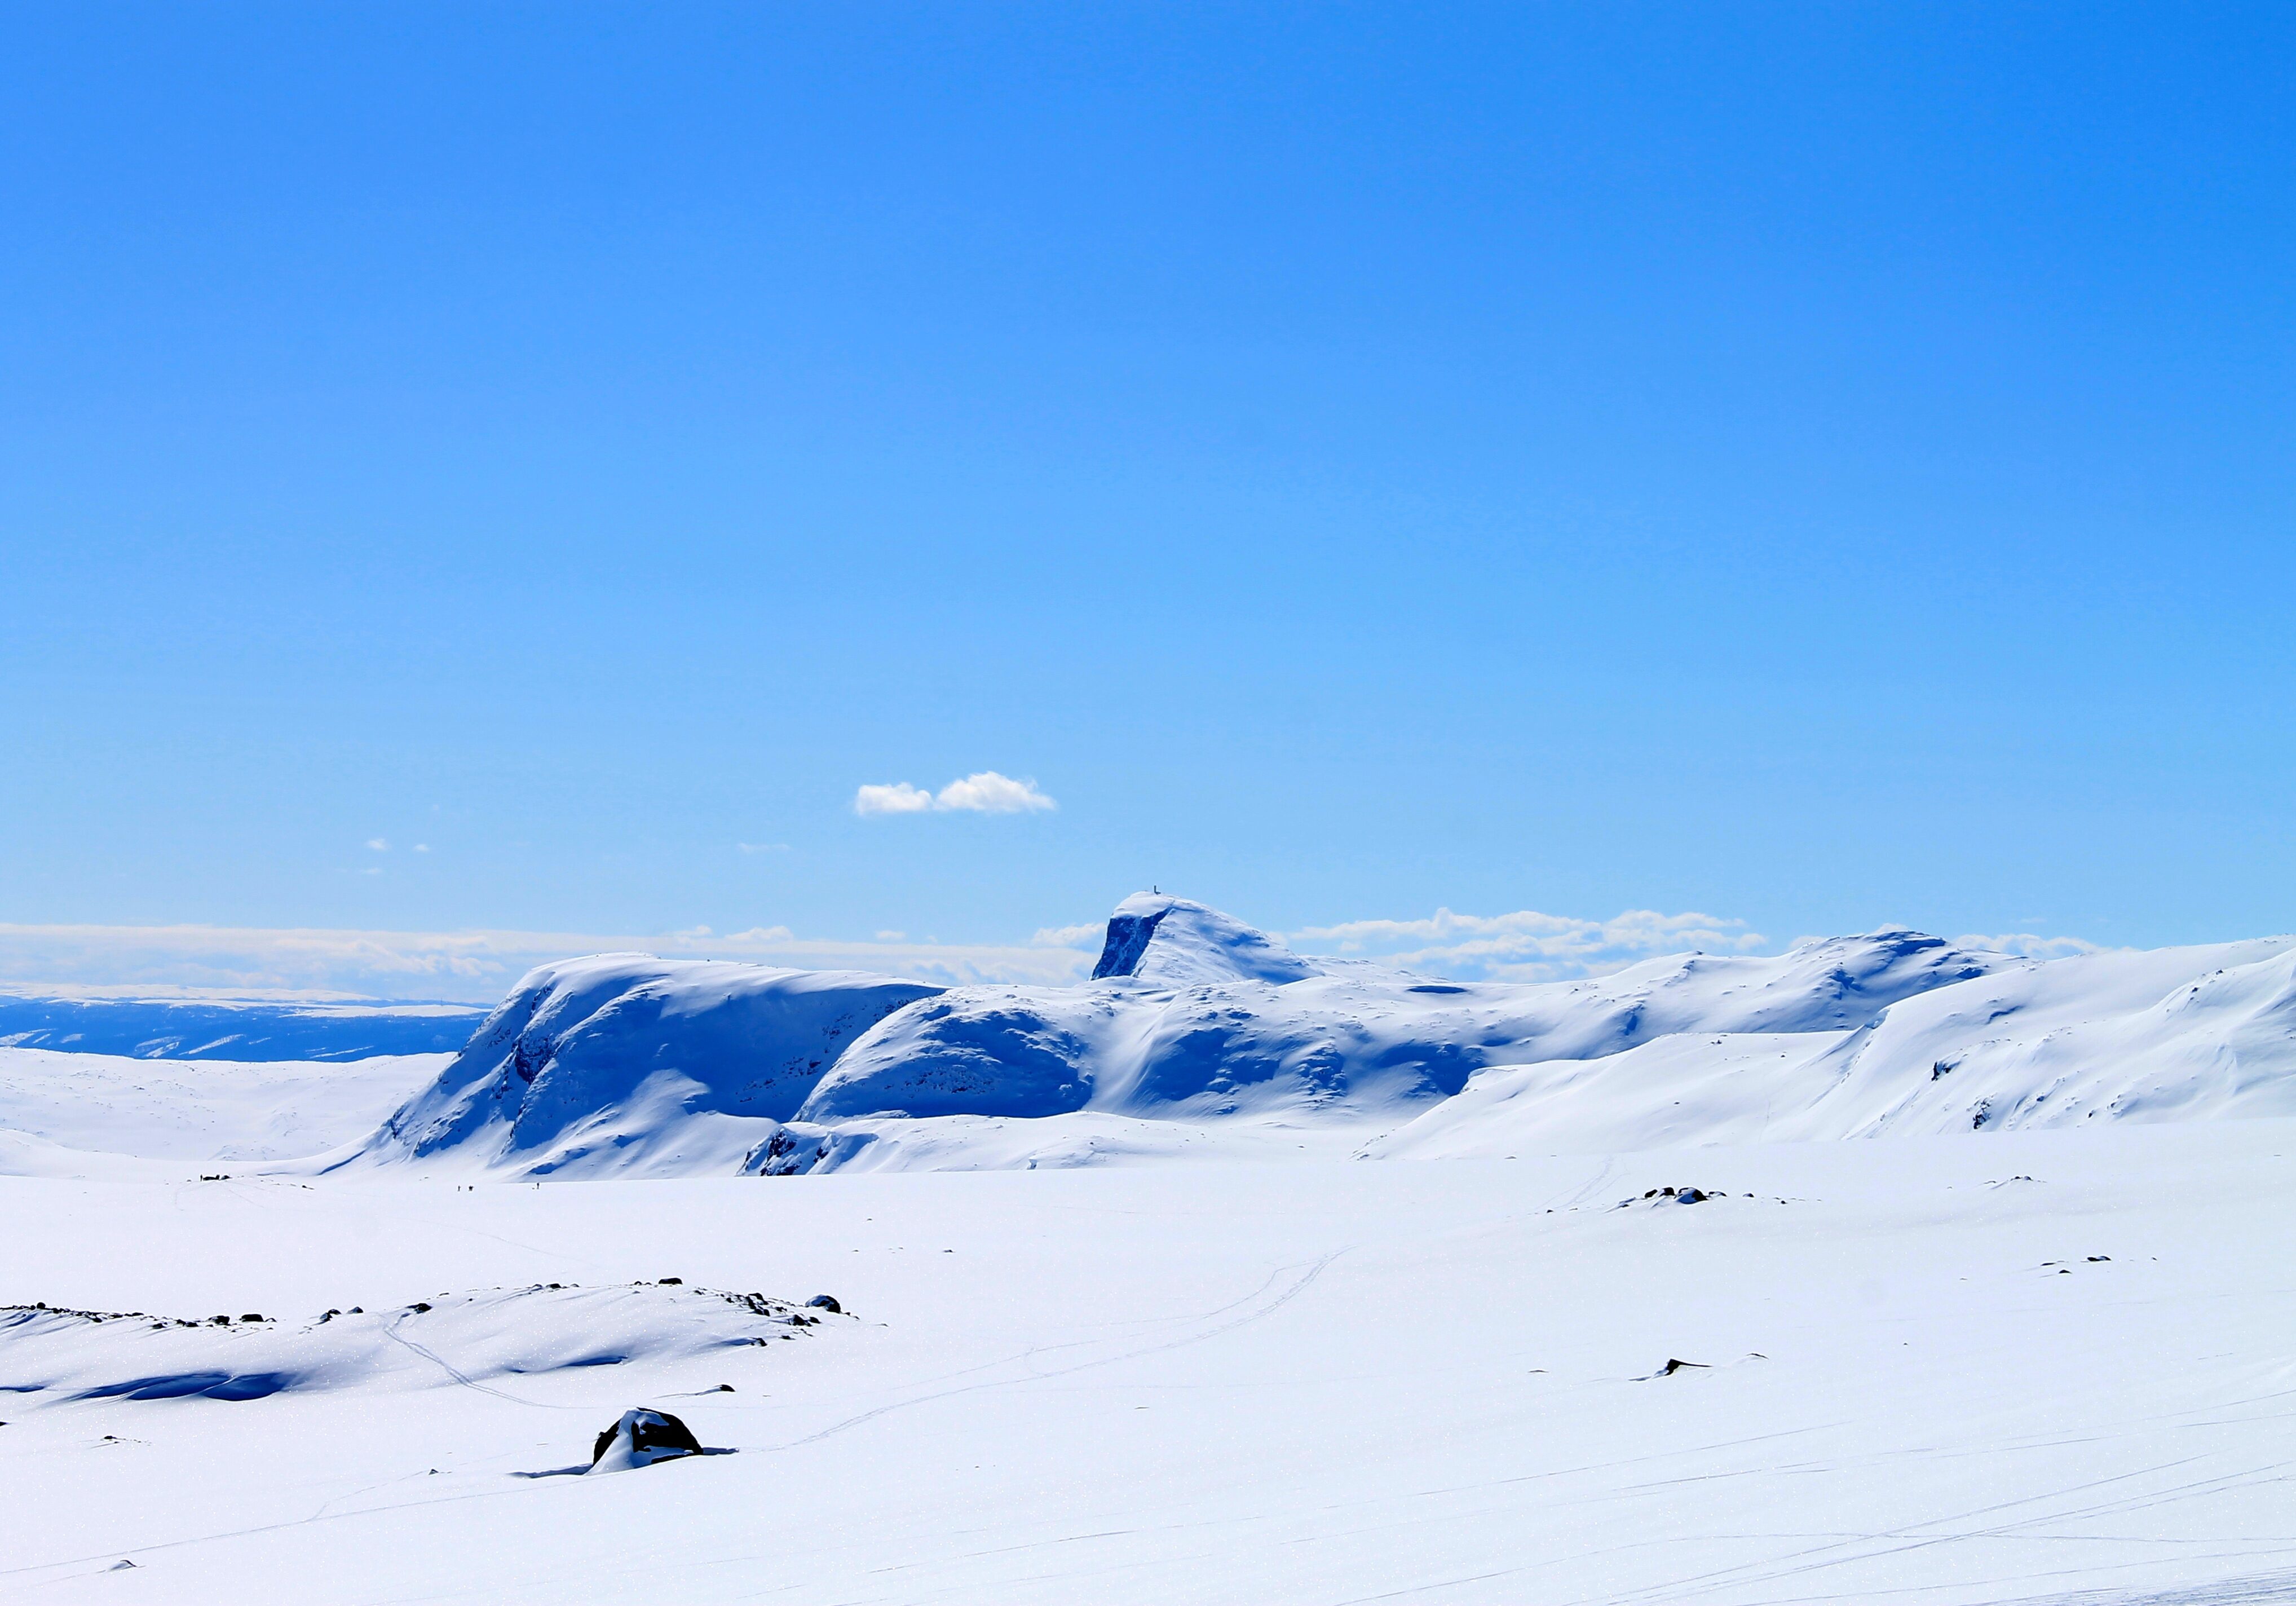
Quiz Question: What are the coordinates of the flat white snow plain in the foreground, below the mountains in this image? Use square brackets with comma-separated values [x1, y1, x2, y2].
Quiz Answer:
[0, 1119, 2296, 1606]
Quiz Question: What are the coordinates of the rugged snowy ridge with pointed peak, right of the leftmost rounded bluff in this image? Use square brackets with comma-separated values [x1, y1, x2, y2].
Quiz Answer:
[799, 919, 2025, 1123]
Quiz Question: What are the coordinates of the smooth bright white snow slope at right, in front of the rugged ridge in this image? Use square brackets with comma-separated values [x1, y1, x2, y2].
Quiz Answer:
[1366, 937, 2296, 1158]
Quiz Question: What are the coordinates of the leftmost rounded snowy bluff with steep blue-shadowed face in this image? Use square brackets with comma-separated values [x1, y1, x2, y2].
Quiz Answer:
[347, 954, 939, 1176]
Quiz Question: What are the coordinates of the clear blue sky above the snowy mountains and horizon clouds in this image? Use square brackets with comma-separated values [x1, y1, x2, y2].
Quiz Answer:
[0, 5, 2296, 990]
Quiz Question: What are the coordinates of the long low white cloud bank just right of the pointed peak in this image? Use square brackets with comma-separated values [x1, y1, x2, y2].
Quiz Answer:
[1288, 910, 1770, 981]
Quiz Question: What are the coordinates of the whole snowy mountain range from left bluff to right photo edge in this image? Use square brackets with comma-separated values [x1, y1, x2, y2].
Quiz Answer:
[72, 894, 2296, 1176]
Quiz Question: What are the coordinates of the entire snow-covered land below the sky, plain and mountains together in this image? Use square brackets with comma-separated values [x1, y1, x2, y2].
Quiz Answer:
[0, 896, 2296, 1606]
